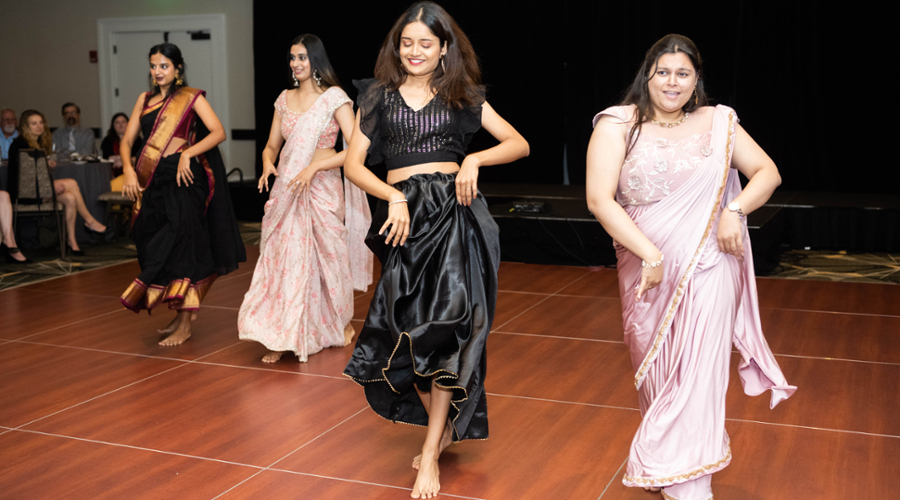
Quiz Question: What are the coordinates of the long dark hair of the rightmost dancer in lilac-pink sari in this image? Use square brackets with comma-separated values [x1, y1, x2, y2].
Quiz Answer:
[621, 33, 709, 156]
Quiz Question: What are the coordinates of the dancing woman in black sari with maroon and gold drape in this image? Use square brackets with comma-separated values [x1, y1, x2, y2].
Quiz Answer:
[119, 43, 247, 346]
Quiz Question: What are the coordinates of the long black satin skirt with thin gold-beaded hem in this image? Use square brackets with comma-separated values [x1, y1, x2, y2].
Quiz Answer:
[344, 173, 500, 441]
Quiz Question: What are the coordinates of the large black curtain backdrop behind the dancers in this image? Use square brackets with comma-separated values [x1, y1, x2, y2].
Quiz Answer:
[254, 0, 900, 193]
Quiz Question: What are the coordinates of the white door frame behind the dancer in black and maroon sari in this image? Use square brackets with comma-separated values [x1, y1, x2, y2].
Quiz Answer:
[97, 14, 231, 161]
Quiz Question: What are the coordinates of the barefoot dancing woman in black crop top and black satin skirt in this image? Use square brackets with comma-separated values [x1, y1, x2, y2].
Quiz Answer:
[344, 2, 528, 498]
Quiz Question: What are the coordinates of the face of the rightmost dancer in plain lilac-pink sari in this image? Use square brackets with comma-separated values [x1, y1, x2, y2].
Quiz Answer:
[647, 52, 697, 119]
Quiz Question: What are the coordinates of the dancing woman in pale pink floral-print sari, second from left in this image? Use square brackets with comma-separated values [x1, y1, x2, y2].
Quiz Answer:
[238, 34, 373, 363]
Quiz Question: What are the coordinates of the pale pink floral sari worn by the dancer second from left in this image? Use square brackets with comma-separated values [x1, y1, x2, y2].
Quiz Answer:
[238, 87, 372, 362]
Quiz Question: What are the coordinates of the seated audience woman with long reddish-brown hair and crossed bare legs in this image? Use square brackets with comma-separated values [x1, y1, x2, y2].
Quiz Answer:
[8, 109, 106, 255]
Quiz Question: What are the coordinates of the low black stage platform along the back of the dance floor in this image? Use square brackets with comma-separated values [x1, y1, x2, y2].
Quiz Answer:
[229, 180, 900, 275]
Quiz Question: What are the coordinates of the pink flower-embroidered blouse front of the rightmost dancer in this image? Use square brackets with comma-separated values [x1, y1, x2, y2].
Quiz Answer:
[616, 131, 712, 206]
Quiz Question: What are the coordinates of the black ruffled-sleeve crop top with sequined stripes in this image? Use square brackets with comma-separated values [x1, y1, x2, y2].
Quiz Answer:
[353, 78, 484, 170]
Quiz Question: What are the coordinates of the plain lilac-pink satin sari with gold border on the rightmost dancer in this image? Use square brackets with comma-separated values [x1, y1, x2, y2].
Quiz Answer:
[595, 106, 796, 500]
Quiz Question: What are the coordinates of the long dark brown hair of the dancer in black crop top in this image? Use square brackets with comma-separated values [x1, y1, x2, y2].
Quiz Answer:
[375, 2, 483, 109]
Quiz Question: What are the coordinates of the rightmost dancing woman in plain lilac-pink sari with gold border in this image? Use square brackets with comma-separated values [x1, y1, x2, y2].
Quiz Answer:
[587, 35, 796, 500]
